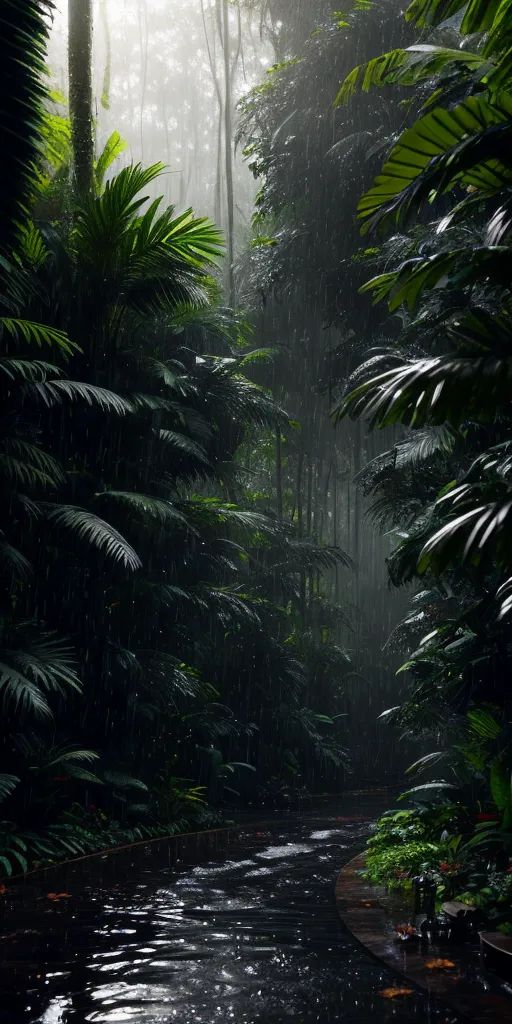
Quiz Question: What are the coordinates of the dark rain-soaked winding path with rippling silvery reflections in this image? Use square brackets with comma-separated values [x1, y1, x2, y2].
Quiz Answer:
[0, 801, 461, 1024]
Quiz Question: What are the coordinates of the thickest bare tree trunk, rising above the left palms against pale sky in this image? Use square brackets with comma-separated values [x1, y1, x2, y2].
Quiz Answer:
[68, 0, 94, 199]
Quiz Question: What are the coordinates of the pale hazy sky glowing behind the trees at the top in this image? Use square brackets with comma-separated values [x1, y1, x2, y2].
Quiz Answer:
[48, 0, 273, 236]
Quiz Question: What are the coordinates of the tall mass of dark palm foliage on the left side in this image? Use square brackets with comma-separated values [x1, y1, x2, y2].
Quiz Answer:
[0, 3, 348, 873]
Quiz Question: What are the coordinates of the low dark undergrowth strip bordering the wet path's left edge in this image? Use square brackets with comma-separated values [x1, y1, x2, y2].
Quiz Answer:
[0, 805, 226, 879]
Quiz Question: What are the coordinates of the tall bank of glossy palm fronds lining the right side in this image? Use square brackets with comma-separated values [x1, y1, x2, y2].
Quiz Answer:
[323, 0, 512, 902]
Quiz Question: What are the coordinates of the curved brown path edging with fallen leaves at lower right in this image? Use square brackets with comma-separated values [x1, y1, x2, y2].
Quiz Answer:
[336, 853, 512, 1024]
